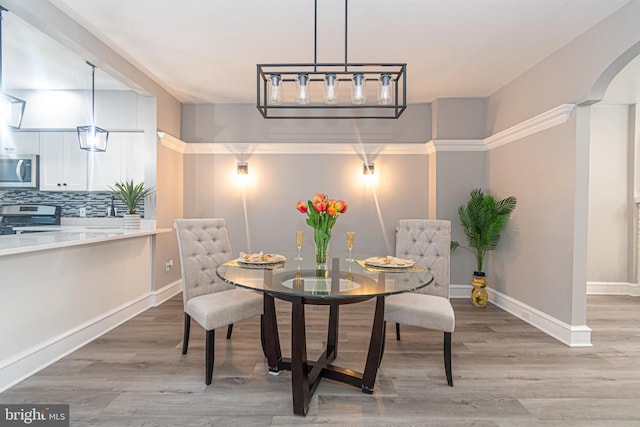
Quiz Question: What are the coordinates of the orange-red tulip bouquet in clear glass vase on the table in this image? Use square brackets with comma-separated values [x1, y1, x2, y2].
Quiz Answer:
[296, 193, 348, 267]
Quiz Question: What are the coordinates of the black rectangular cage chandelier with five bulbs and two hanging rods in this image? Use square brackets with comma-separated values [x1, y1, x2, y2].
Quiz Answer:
[256, 0, 407, 119]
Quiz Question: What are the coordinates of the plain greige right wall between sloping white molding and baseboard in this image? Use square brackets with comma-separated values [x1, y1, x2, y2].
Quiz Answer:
[487, 118, 576, 324]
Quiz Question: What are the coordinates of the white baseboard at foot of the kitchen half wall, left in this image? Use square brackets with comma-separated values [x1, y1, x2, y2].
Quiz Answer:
[0, 292, 158, 392]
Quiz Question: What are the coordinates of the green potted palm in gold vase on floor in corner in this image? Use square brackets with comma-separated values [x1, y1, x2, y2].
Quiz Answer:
[451, 188, 517, 307]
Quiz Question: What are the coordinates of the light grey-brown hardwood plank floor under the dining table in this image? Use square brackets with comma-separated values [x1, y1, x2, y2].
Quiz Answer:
[0, 295, 640, 427]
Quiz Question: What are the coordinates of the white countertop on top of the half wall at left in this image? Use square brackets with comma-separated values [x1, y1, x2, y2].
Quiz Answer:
[0, 221, 171, 256]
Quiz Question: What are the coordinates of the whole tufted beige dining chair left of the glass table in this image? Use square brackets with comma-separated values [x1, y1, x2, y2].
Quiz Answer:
[173, 218, 263, 385]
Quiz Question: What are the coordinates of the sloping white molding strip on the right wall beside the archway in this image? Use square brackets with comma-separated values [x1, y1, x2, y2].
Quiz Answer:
[484, 104, 576, 150]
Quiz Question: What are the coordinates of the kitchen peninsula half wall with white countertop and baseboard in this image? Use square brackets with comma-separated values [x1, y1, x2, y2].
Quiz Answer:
[0, 218, 180, 392]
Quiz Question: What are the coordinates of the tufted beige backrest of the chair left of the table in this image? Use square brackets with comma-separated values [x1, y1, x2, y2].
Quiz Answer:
[173, 218, 233, 304]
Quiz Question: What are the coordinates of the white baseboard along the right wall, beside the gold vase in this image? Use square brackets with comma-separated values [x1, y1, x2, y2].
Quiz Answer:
[487, 288, 591, 347]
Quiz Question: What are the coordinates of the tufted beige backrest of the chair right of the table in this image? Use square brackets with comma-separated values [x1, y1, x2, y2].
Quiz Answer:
[396, 219, 451, 298]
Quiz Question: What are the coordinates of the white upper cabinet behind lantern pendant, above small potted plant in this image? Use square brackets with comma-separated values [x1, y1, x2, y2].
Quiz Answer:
[88, 132, 146, 191]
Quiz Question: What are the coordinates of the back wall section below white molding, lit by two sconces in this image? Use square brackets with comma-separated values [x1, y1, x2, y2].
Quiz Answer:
[184, 154, 428, 256]
